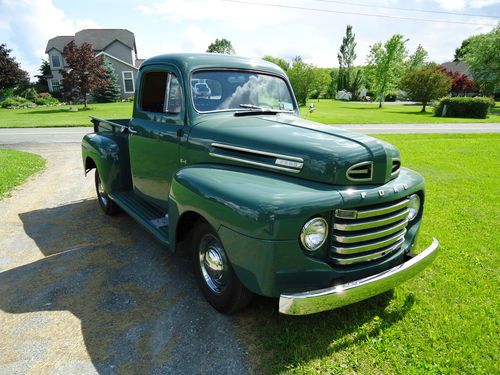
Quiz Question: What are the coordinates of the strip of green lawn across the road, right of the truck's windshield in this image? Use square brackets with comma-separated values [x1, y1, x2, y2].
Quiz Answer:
[301, 99, 500, 124]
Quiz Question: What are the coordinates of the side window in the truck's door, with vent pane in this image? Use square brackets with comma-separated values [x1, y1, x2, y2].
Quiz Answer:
[140, 72, 182, 114]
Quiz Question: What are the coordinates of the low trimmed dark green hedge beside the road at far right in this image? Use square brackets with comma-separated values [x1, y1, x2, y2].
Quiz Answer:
[434, 97, 495, 118]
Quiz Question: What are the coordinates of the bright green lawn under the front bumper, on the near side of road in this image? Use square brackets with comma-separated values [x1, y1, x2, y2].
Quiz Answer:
[242, 134, 500, 374]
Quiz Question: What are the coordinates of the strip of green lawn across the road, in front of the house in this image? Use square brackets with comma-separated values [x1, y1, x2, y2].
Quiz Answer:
[0, 102, 132, 128]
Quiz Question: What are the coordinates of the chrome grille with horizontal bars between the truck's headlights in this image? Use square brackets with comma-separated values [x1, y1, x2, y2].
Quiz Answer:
[330, 198, 409, 265]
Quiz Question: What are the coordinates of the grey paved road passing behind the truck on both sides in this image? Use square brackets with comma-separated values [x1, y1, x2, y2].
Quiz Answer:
[0, 123, 500, 144]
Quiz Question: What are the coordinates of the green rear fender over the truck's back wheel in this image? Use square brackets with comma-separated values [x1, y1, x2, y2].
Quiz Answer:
[82, 133, 132, 192]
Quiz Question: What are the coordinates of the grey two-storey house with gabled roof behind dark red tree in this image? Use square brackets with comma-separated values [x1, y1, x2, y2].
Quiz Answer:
[45, 29, 144, 98]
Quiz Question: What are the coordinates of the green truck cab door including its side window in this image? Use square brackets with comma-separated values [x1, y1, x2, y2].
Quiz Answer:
[129, 67, 185, 212]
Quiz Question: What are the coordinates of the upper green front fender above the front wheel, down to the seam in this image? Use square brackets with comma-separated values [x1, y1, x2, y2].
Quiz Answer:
[170, 164, 342, 240]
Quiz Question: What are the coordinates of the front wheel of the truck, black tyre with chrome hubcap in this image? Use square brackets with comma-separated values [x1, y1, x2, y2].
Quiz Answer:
[192, 222, 253, 314]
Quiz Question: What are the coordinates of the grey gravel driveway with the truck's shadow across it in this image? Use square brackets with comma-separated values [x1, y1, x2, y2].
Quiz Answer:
[0, 143, 250, 375]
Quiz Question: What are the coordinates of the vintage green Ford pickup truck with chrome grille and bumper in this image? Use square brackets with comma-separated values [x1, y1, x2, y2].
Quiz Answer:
[82, 54, 439, 315]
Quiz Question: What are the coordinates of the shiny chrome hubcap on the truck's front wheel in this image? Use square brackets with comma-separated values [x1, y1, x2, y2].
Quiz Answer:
[198, 234, 228, 294]
